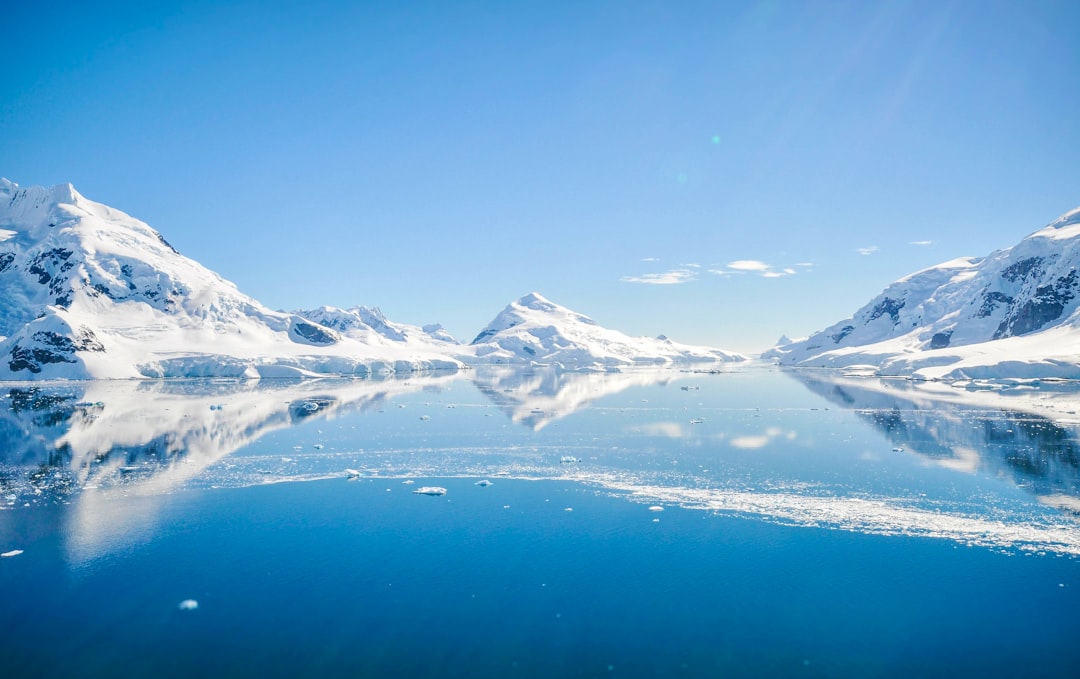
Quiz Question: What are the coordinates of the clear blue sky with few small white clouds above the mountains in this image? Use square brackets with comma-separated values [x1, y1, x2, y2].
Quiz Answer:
[0, 0, 1080, 351]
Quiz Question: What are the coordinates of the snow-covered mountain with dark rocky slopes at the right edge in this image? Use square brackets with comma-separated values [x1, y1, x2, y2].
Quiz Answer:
[765, 208, 1080, 379]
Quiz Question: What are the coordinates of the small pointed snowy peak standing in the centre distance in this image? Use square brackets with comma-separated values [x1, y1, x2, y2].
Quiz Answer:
[472, 293, 745, 368]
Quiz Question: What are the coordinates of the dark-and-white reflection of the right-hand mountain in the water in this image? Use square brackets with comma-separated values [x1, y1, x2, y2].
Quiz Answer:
[791, 371, 1080, 512]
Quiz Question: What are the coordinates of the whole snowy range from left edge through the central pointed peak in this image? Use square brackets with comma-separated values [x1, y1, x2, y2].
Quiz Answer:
[0, 179, 745, 380]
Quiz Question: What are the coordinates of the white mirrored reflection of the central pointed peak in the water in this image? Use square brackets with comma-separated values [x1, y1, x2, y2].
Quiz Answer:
[472, 366, 679, 432]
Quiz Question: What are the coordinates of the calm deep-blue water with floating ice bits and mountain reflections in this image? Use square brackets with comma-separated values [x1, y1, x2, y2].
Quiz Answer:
[0, 369, 1080, 677]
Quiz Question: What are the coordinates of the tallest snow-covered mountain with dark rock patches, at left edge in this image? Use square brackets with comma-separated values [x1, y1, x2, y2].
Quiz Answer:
[0, 179, 460, 380]
